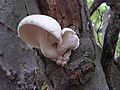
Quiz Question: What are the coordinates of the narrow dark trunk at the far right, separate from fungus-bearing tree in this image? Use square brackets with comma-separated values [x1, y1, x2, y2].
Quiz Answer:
[101, 0, 120, 90]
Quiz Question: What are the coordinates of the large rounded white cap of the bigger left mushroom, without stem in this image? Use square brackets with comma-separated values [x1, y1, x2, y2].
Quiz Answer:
[18, 15, 62, 48]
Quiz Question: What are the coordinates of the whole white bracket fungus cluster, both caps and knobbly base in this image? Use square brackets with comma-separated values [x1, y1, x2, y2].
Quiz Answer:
[18, 15, 79, 66]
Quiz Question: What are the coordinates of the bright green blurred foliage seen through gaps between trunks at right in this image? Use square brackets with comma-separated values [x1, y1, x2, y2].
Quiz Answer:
[87, 0, 120, 57]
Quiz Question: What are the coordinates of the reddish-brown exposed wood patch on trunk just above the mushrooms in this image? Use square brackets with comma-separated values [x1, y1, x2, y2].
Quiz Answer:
[38, 0, 81, 29]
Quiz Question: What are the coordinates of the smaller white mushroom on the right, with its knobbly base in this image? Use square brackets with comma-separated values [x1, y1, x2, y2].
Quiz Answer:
[57, 28, 79, 66]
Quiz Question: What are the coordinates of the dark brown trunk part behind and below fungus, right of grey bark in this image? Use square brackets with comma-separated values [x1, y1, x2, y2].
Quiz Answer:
[38, 0, 108, 90]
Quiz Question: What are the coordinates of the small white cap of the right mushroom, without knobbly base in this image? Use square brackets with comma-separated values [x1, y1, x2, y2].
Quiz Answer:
[58, 28, 79, 54]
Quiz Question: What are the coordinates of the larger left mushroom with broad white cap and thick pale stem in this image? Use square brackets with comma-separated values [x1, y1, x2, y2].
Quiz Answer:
[18, 15, 62, 60]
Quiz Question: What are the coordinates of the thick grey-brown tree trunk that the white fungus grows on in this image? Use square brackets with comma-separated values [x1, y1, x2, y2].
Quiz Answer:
[0, 0, 119, 90]
